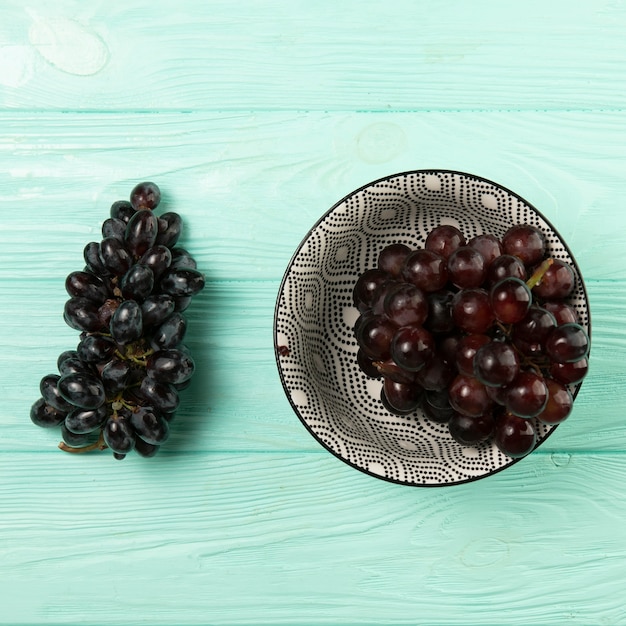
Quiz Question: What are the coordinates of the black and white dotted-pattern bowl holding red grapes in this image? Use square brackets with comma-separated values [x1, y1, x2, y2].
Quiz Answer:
[274, 170, 590, 486]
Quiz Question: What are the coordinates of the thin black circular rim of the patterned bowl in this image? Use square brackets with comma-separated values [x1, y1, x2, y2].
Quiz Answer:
[272, 168, 592, 488]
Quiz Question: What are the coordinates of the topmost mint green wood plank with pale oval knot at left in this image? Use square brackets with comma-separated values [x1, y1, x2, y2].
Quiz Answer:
[0, 0, 626, 111]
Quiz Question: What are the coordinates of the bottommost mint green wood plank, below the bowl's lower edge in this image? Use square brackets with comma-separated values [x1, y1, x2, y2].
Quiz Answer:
[0, 453, 626, 626]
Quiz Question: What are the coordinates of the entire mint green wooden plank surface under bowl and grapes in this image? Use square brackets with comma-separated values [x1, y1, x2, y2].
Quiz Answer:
[0, 0, 626, 626]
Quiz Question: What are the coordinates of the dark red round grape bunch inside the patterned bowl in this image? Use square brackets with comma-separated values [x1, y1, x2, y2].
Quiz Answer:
[353, 224, 589, 458]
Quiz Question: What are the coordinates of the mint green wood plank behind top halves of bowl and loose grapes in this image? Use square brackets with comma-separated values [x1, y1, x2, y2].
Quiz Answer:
[0, 111, 626, 281]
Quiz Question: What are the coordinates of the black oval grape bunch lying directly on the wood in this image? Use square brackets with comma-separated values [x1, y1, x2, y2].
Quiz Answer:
[30, 182, 205, 459]
